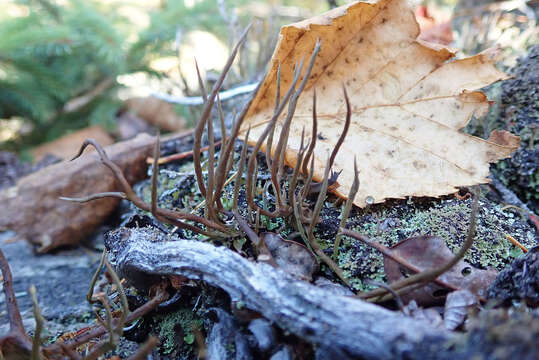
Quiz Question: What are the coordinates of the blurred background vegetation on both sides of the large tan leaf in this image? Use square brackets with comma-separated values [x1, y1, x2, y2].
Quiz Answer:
[0, 0, 537, 152]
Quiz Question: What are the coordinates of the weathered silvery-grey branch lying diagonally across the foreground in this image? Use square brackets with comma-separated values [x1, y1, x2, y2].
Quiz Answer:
[105, 228, 452, 359]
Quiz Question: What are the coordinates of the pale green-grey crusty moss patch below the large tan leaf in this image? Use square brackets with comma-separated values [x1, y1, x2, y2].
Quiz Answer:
[318, 199, 536, 290]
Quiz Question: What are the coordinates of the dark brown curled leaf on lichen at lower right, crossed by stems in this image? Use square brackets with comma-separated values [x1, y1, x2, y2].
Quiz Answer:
[384, 236, 497, 305]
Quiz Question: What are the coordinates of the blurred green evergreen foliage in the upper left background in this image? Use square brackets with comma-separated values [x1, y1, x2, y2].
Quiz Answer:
[0, 0, 327, 150]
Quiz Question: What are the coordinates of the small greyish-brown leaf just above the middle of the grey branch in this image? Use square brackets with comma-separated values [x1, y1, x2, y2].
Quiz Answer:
[260, 233, 318, 280]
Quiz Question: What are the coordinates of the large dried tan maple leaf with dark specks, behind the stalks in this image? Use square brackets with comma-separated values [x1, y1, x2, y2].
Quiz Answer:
[242, 0, 519, 206]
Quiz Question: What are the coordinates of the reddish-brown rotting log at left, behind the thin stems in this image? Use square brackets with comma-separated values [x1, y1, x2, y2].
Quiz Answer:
[0, 134, 155, 252]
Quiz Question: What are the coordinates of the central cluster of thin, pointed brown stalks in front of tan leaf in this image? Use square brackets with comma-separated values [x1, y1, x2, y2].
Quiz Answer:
[62, 29, 476, 300]
